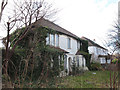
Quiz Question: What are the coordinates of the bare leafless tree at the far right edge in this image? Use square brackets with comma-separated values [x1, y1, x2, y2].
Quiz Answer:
[108, 23, 120, 88]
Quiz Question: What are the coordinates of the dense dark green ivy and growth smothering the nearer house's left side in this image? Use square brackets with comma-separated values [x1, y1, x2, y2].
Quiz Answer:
[2, 26, 64, 80]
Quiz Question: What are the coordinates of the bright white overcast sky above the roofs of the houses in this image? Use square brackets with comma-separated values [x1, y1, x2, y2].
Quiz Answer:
[0, 0, 119, 46]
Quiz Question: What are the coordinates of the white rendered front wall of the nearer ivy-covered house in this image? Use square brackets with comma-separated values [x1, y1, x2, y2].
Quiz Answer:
[46, 34, 86, 72]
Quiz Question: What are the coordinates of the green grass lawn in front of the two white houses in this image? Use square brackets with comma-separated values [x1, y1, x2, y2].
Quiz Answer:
[56, 71, 119, 88]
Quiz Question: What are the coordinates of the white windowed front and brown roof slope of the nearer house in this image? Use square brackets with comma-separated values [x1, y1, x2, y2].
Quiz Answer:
[36, 19, 88, 74]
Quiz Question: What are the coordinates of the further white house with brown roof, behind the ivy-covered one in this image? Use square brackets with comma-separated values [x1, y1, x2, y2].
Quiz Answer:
[82, 37, 110, 64]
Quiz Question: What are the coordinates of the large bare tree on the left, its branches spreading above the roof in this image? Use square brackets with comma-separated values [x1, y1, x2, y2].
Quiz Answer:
[3, 0, 56, 87]
